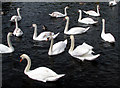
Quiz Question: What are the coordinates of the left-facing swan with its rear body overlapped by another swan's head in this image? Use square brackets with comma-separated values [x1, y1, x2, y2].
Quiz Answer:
[32, 24, 59, 41]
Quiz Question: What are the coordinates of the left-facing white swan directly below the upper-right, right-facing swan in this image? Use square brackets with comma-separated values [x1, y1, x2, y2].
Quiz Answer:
[78, 10, 98, 24]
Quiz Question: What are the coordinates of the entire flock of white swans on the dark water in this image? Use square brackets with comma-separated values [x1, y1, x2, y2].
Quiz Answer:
[0, 0, 115, 82]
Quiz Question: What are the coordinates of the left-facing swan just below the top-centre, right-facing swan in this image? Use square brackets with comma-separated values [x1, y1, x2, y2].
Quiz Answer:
[64, 16, 90, 35]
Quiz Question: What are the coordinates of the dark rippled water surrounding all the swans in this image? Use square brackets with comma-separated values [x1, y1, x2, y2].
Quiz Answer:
[2, 2, 120, 88]
